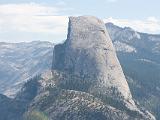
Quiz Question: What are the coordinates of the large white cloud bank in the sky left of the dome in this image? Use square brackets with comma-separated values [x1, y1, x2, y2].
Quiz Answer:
[0, 2, 68, 42]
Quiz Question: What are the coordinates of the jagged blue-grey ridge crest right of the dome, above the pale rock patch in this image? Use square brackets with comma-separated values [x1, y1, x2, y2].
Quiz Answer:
[106, 23, 160, 55]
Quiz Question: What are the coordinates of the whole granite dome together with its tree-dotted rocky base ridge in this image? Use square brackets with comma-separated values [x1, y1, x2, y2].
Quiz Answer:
[22, 16, 154, 120]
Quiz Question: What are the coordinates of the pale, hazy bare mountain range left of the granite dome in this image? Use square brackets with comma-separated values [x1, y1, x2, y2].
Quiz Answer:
[0, 41, 53, 97]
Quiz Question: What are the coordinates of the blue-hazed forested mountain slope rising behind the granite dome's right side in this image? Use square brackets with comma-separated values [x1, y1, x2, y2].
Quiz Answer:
[106, 23, 160, 119]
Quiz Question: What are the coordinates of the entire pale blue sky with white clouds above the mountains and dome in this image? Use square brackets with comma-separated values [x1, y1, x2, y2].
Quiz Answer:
[0, 0, 160, 42]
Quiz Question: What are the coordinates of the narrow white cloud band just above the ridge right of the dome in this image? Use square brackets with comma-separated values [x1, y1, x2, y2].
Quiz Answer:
[104, 17, 160, 34]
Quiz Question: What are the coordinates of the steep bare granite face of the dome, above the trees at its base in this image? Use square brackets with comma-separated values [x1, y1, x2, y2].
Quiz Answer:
[53, 16, 136, 109]
